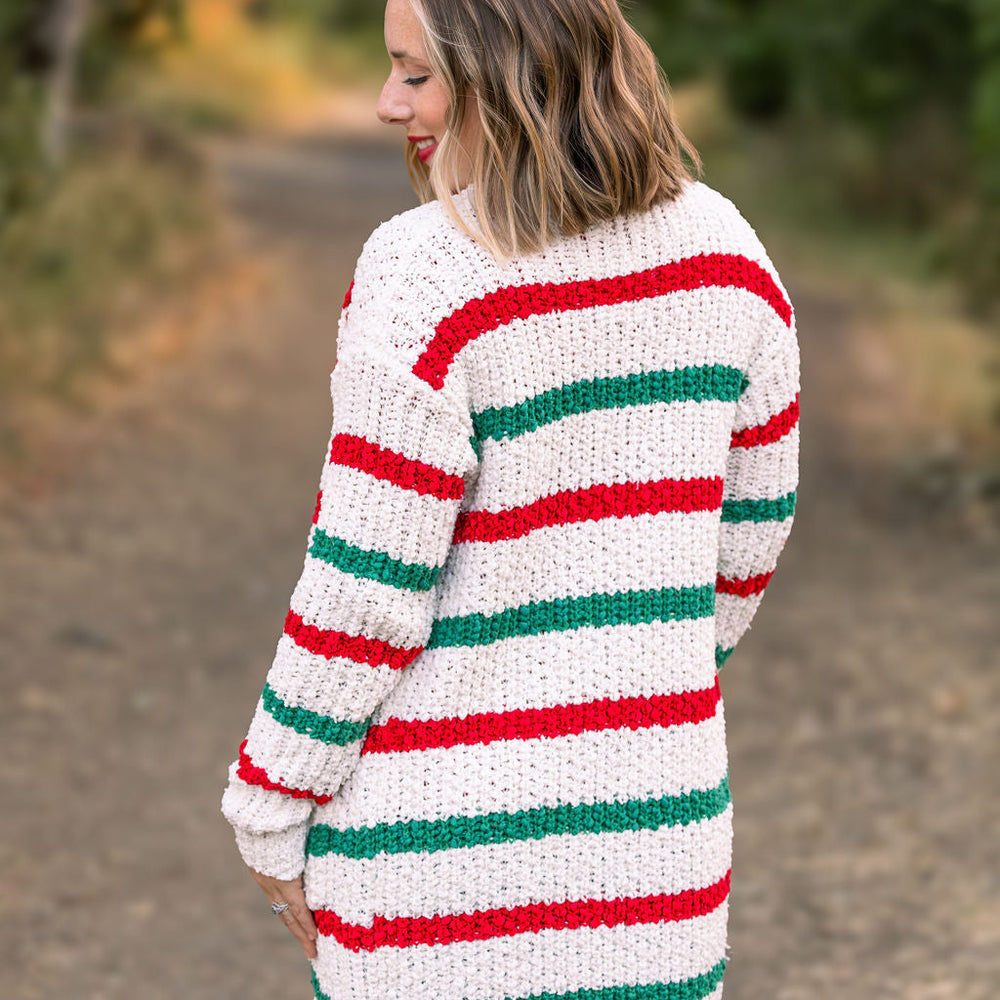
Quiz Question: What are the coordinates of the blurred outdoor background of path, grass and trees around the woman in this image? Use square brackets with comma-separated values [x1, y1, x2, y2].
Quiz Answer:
[0, 0, 1000, 1000]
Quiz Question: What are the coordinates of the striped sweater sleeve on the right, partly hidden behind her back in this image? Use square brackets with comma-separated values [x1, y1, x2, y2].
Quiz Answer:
[715, 300, 799, 667]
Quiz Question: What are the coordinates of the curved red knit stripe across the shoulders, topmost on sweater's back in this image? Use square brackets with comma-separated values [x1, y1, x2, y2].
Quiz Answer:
[413, 253, 792, 389]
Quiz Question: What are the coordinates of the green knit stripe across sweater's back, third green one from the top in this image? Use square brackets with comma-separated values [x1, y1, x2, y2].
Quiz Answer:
[306, 776, 730, 858]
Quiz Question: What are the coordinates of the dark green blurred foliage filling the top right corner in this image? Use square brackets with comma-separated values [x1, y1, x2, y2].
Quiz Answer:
[623, 0, 1000, 316]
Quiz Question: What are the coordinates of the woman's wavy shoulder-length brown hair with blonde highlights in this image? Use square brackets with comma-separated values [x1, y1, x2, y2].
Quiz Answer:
[406, 0, 702, 260]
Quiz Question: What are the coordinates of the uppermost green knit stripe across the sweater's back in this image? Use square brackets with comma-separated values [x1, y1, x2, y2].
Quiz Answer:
[472, 365, 747, 438]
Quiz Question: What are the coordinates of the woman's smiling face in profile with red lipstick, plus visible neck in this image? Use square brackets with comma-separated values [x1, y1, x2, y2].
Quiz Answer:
[376, 0, 481, 186]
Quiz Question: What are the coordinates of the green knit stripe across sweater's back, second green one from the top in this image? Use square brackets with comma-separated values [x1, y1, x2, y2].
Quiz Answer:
[425, 584, 715, 649]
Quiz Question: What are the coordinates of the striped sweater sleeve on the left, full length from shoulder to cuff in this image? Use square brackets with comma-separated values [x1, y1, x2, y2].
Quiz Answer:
[222, 230, 477, 879]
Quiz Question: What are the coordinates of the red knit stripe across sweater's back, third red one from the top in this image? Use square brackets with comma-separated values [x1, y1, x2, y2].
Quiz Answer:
[361, 680, 719, 753]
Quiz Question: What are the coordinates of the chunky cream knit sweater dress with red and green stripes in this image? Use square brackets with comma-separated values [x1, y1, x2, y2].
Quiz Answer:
[222, 181, 799, 1000]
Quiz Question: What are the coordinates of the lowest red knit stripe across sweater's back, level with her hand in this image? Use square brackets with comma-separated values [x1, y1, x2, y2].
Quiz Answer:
[313, 872, 730, 951]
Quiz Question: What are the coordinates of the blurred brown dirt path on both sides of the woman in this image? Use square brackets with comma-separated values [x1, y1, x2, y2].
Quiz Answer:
[0, 139, 1000, 1000]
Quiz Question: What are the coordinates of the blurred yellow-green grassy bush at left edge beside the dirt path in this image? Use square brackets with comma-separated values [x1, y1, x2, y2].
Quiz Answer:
[0, 135, 219, 445]
